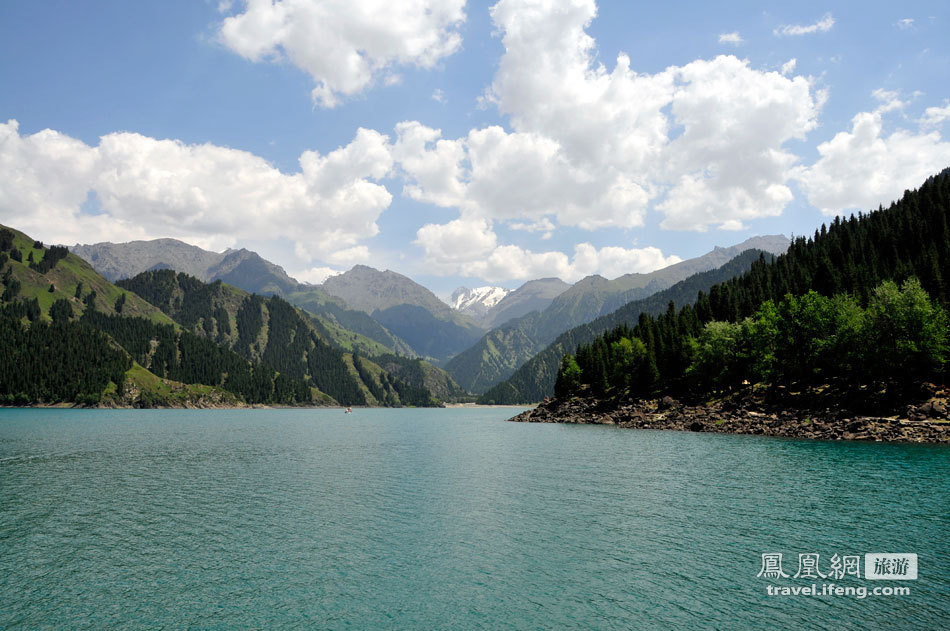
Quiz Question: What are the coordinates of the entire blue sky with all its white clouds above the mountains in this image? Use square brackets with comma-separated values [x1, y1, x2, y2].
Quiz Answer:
[0, 0, 950, 295]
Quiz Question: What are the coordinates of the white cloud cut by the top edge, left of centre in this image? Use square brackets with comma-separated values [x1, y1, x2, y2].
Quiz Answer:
[218, 0, 465, 107]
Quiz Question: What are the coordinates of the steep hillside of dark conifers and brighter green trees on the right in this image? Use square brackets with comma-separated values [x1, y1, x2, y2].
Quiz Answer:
[556, 170, 950, 410]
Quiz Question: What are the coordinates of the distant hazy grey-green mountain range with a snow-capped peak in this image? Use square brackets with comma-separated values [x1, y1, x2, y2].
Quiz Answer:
[71, 235, 788, 394]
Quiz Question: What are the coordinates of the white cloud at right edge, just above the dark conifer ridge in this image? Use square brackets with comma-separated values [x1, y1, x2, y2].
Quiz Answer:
[798, 111, 950, 215]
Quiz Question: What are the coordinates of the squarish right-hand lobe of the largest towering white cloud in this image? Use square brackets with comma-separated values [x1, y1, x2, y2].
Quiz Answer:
[657, 57, 820, 230]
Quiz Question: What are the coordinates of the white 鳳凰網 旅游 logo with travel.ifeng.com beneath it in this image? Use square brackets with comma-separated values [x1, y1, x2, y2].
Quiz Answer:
[756, 552, 917, 598]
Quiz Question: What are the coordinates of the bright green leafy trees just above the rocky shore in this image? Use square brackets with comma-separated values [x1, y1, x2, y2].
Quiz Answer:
[555, 279, 950, 398]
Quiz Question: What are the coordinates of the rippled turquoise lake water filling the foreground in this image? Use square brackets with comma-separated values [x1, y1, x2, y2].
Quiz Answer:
[0, 409, 950, 631]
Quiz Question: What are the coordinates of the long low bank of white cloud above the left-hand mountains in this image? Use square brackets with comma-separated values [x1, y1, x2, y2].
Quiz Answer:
[0, 121, 392, 262]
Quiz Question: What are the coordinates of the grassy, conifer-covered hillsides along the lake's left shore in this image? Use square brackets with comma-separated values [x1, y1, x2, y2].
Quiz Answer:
[0, 228, 436, 406]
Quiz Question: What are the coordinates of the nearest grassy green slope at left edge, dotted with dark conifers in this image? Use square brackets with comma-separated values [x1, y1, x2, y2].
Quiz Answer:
[0, 227, 255, 407]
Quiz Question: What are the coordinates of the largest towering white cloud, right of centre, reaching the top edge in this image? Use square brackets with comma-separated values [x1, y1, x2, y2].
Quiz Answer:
[492, 0, 823, 230]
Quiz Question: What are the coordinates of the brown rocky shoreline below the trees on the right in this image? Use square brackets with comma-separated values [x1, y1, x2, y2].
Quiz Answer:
[509, 392, 950, 444]
